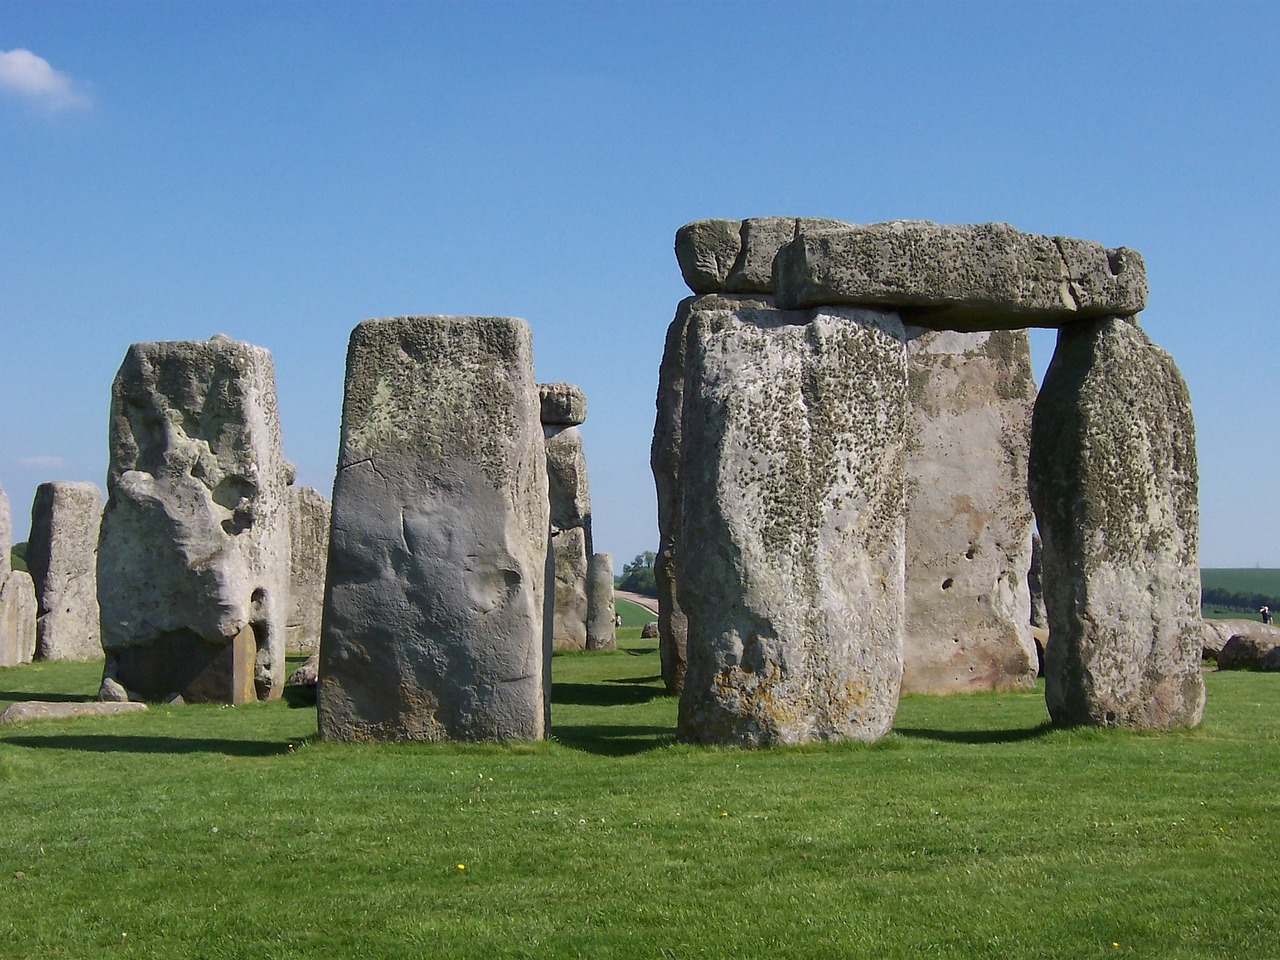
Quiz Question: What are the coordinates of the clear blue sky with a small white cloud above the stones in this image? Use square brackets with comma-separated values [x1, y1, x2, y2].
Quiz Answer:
[0, 0, 1280, 567]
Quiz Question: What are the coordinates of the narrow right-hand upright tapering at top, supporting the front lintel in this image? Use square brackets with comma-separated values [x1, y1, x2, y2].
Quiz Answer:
[1029, 319, 1204, 728]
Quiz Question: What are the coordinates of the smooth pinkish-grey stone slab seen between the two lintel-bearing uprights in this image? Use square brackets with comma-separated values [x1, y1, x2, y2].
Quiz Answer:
[902, 329, 1038, 694]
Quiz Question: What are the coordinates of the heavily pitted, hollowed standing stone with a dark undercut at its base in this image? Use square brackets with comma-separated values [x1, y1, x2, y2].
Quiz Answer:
[97, 335, 292, 703]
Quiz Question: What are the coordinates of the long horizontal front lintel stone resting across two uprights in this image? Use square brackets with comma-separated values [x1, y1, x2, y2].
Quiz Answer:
[773, 220, 1147, 330]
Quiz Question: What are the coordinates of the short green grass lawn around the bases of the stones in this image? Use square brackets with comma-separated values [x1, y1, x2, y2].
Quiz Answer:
[0, 627, 1280, 960]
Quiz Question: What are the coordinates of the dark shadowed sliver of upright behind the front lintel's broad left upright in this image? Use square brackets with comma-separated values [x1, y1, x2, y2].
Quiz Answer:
[649, 304, 696, 694]
